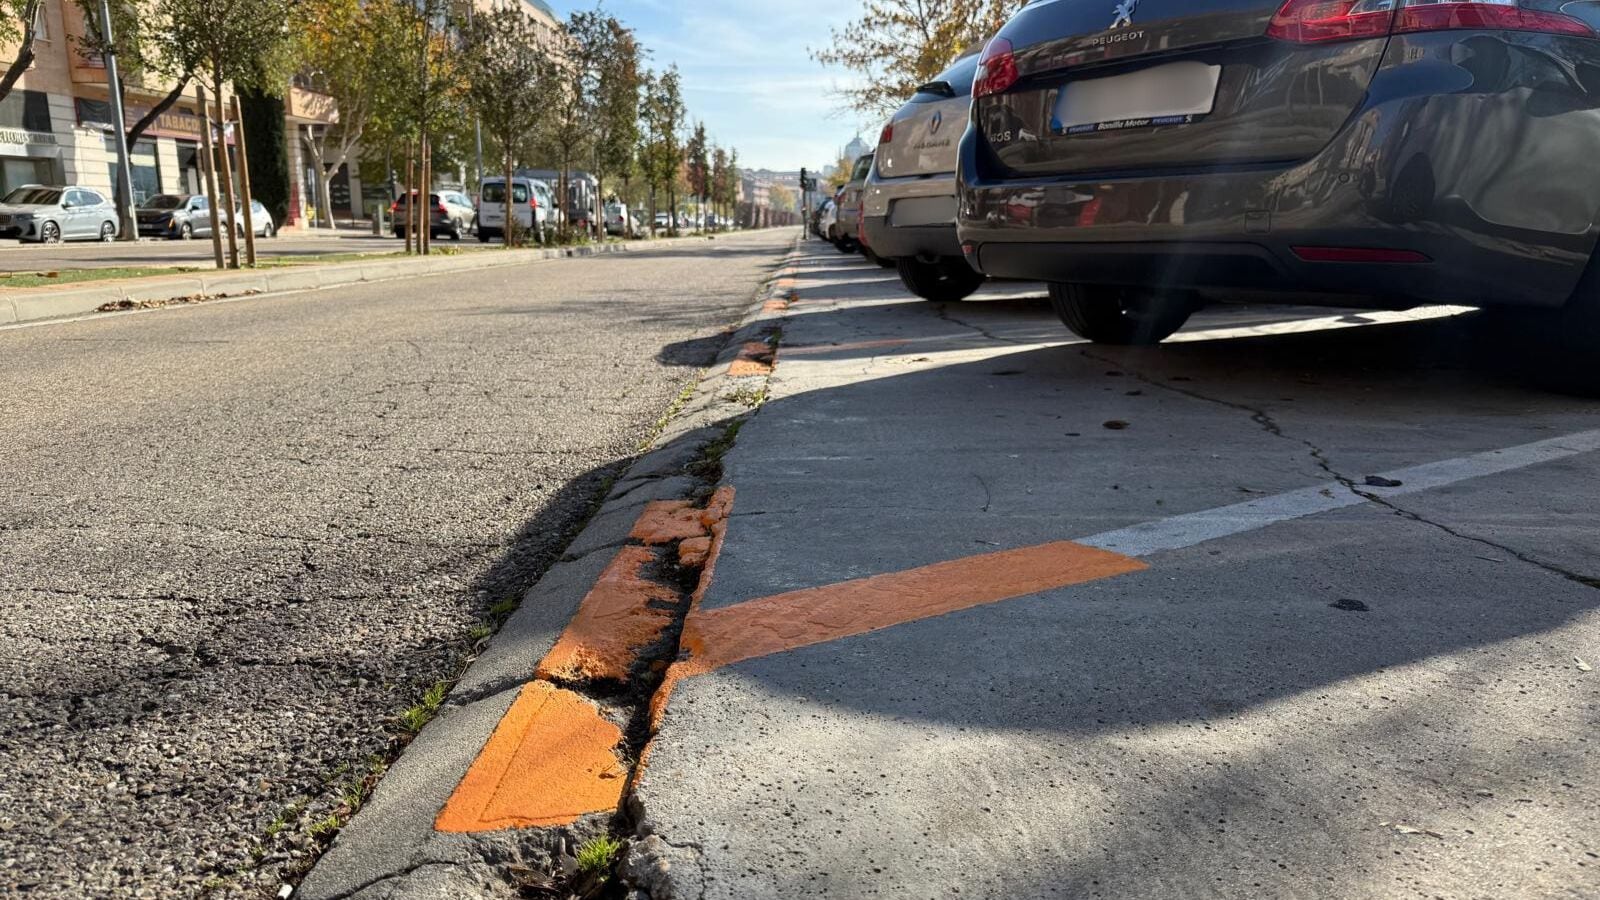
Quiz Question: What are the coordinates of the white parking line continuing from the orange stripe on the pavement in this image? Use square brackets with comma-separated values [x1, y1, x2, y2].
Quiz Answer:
[1074, 429, 1600, 556]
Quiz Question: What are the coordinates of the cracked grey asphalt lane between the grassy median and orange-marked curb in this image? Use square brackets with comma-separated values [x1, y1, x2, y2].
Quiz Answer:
[0, 232, 794, 898]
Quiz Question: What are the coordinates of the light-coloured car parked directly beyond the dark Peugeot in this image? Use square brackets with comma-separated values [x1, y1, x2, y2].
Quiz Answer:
[861, 48, 984, 303]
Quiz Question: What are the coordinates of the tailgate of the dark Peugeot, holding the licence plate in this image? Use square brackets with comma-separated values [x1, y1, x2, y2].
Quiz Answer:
[976, 0, 1394, 175]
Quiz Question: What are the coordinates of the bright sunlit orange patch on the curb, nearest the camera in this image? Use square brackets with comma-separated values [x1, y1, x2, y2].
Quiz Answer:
[434, 681, 627, 834]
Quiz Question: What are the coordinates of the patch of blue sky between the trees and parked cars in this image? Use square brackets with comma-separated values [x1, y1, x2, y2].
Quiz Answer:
[549, 0, 878, 170]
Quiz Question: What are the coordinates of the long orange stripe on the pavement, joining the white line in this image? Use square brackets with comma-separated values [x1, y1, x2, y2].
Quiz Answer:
[674, 541, 1149, 677]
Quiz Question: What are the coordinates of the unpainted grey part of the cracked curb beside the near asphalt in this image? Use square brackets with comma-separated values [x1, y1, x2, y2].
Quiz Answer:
[294, 235, 797, 900]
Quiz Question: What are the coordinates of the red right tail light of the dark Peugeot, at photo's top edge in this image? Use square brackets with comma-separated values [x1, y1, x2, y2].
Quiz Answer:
[1267, 0, 1597, 43]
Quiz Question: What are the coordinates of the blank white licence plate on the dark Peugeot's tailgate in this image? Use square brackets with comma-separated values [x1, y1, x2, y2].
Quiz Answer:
[1051, 62, 1222, 135]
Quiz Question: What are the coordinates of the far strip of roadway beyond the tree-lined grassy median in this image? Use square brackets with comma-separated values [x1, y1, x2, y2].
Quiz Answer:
[0, 231, 498, 272]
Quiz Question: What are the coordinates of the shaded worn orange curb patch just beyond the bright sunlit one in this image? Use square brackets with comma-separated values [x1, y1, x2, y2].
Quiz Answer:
[536, 538, 681, 681]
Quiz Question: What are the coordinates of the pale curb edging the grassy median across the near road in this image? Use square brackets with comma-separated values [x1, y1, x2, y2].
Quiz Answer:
[0, 230, 736, 325]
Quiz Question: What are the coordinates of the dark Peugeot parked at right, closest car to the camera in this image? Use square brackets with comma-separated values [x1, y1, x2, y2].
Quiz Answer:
[958, 0, 1600, 343]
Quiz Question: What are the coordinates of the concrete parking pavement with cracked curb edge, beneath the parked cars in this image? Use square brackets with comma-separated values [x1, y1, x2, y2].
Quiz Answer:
[301, 235, 1600, 900]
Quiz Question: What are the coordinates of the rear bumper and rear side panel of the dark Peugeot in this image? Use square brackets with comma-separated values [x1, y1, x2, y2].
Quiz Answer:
[958, 32, 1600, 307]
